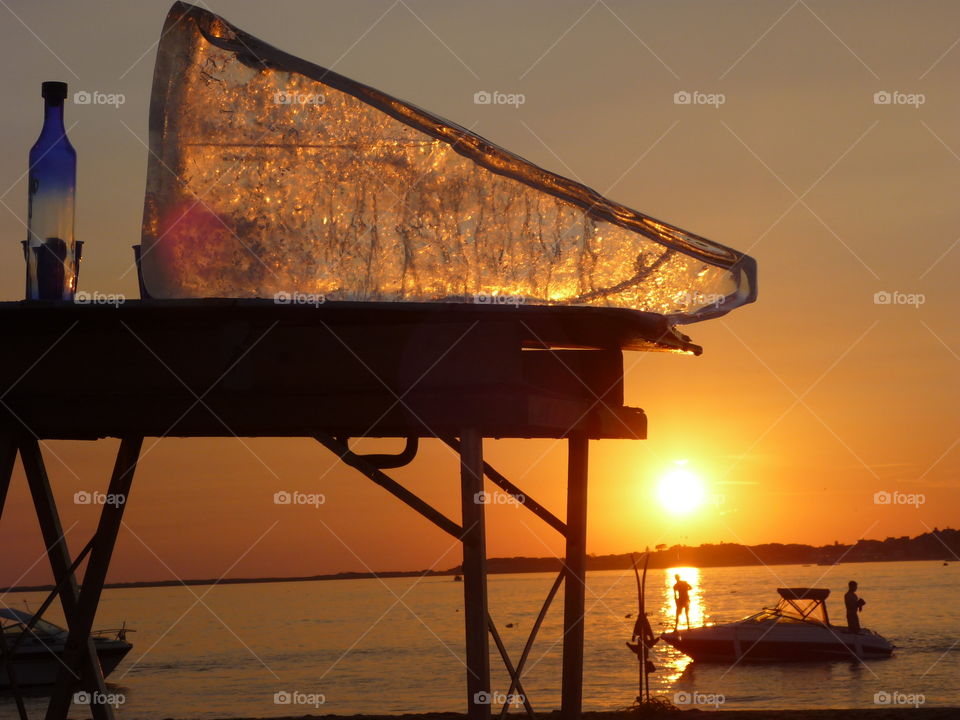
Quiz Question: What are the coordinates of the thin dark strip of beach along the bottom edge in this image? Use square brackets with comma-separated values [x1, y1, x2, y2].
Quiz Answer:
[208, 706, 960, 720]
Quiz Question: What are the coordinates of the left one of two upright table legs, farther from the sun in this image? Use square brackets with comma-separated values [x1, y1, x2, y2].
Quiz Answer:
[460, 428, 490, 720]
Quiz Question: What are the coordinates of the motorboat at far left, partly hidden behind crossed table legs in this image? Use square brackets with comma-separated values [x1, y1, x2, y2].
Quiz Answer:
[0, 608, 133, 688]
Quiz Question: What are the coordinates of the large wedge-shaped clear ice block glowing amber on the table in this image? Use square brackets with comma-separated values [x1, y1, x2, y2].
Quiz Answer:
[141, 2, 756, 322]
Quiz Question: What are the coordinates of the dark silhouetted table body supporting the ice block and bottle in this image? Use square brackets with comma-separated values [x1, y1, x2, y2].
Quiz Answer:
[0, 300, 700, 439]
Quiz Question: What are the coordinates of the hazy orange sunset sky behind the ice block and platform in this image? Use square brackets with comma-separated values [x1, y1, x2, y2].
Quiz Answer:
[0, 0, 960, 585]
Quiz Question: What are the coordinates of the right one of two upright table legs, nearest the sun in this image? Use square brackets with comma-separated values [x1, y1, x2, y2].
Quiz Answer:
[560, 433, 590, 720]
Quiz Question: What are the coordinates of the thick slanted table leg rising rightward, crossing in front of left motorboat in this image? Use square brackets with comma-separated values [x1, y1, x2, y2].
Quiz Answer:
[47, 437, 143, 720]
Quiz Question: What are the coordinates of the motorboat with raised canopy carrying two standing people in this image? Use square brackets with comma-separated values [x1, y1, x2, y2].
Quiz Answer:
[661, 588, 893, 662]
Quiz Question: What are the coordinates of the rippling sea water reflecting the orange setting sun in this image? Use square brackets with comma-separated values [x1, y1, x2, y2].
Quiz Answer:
[0, 562, 960, 720]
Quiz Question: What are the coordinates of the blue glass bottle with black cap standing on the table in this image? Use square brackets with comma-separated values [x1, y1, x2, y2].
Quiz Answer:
[26, 82, 78, 300]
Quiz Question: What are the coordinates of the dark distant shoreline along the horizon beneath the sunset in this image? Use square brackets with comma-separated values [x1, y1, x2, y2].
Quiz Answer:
[0, 528, 960, 593]
